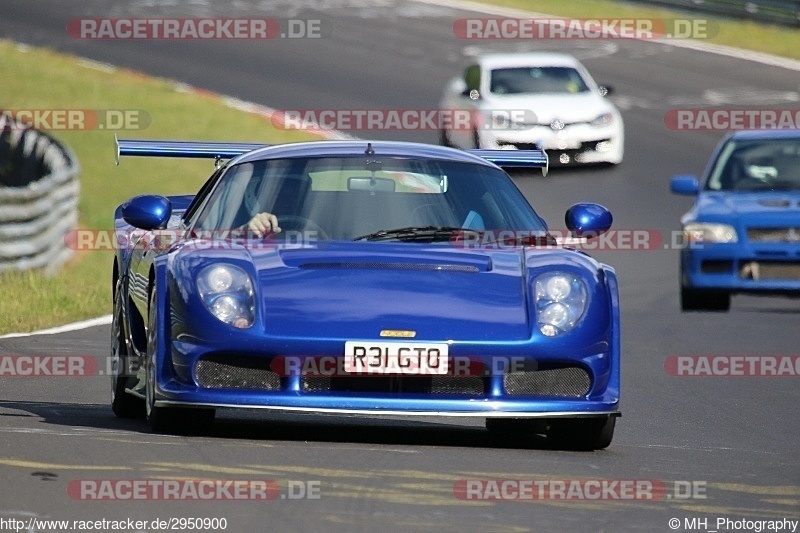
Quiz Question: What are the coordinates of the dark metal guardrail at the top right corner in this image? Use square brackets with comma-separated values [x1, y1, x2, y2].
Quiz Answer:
[633, 0, 800, 27]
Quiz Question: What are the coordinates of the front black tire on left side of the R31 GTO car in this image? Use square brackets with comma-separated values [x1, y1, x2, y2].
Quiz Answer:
[145, 287, 215, 434]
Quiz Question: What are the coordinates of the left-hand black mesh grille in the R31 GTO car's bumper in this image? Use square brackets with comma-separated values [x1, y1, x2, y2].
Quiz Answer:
[195, 357, 281, 391]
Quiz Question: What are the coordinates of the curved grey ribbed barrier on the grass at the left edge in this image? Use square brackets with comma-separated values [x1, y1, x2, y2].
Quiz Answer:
[0, 123, 80, 274]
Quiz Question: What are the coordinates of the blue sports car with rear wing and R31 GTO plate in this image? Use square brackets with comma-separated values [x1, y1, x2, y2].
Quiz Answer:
[111, 140, 620, 449]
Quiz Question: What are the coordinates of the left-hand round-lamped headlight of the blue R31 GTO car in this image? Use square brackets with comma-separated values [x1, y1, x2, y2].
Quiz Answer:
[197, 264, 256, 328]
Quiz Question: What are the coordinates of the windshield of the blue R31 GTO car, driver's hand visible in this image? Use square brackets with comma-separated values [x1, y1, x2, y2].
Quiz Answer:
[194, 156, 546, 241]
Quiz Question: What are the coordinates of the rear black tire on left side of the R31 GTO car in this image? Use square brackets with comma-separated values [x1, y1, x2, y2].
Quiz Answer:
[111, 280, 144, 418]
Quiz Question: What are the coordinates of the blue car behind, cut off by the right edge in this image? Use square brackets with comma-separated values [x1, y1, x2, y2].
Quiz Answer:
[671, 130, 800, 311]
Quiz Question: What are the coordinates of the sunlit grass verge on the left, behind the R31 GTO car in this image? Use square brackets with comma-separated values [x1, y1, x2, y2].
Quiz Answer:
[0, 40, 319, 334]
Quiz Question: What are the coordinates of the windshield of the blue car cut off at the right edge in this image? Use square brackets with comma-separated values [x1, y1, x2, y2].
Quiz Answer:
[706, 139, 800, 191]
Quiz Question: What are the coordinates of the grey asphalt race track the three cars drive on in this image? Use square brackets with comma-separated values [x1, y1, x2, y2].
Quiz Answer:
[0, 0, 800, 532]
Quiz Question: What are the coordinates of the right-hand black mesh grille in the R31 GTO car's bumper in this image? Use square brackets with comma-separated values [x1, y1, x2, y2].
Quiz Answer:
[503, 366, 592, 398]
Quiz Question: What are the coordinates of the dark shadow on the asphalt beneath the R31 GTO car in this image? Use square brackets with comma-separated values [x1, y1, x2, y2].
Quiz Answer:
[0, 400, 604, 450]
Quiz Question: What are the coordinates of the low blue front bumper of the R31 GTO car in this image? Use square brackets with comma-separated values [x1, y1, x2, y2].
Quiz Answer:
[156, 343, 620, 418]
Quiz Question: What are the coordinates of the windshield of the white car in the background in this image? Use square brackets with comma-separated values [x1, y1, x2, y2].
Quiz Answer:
[489, 67, 589, 94]
